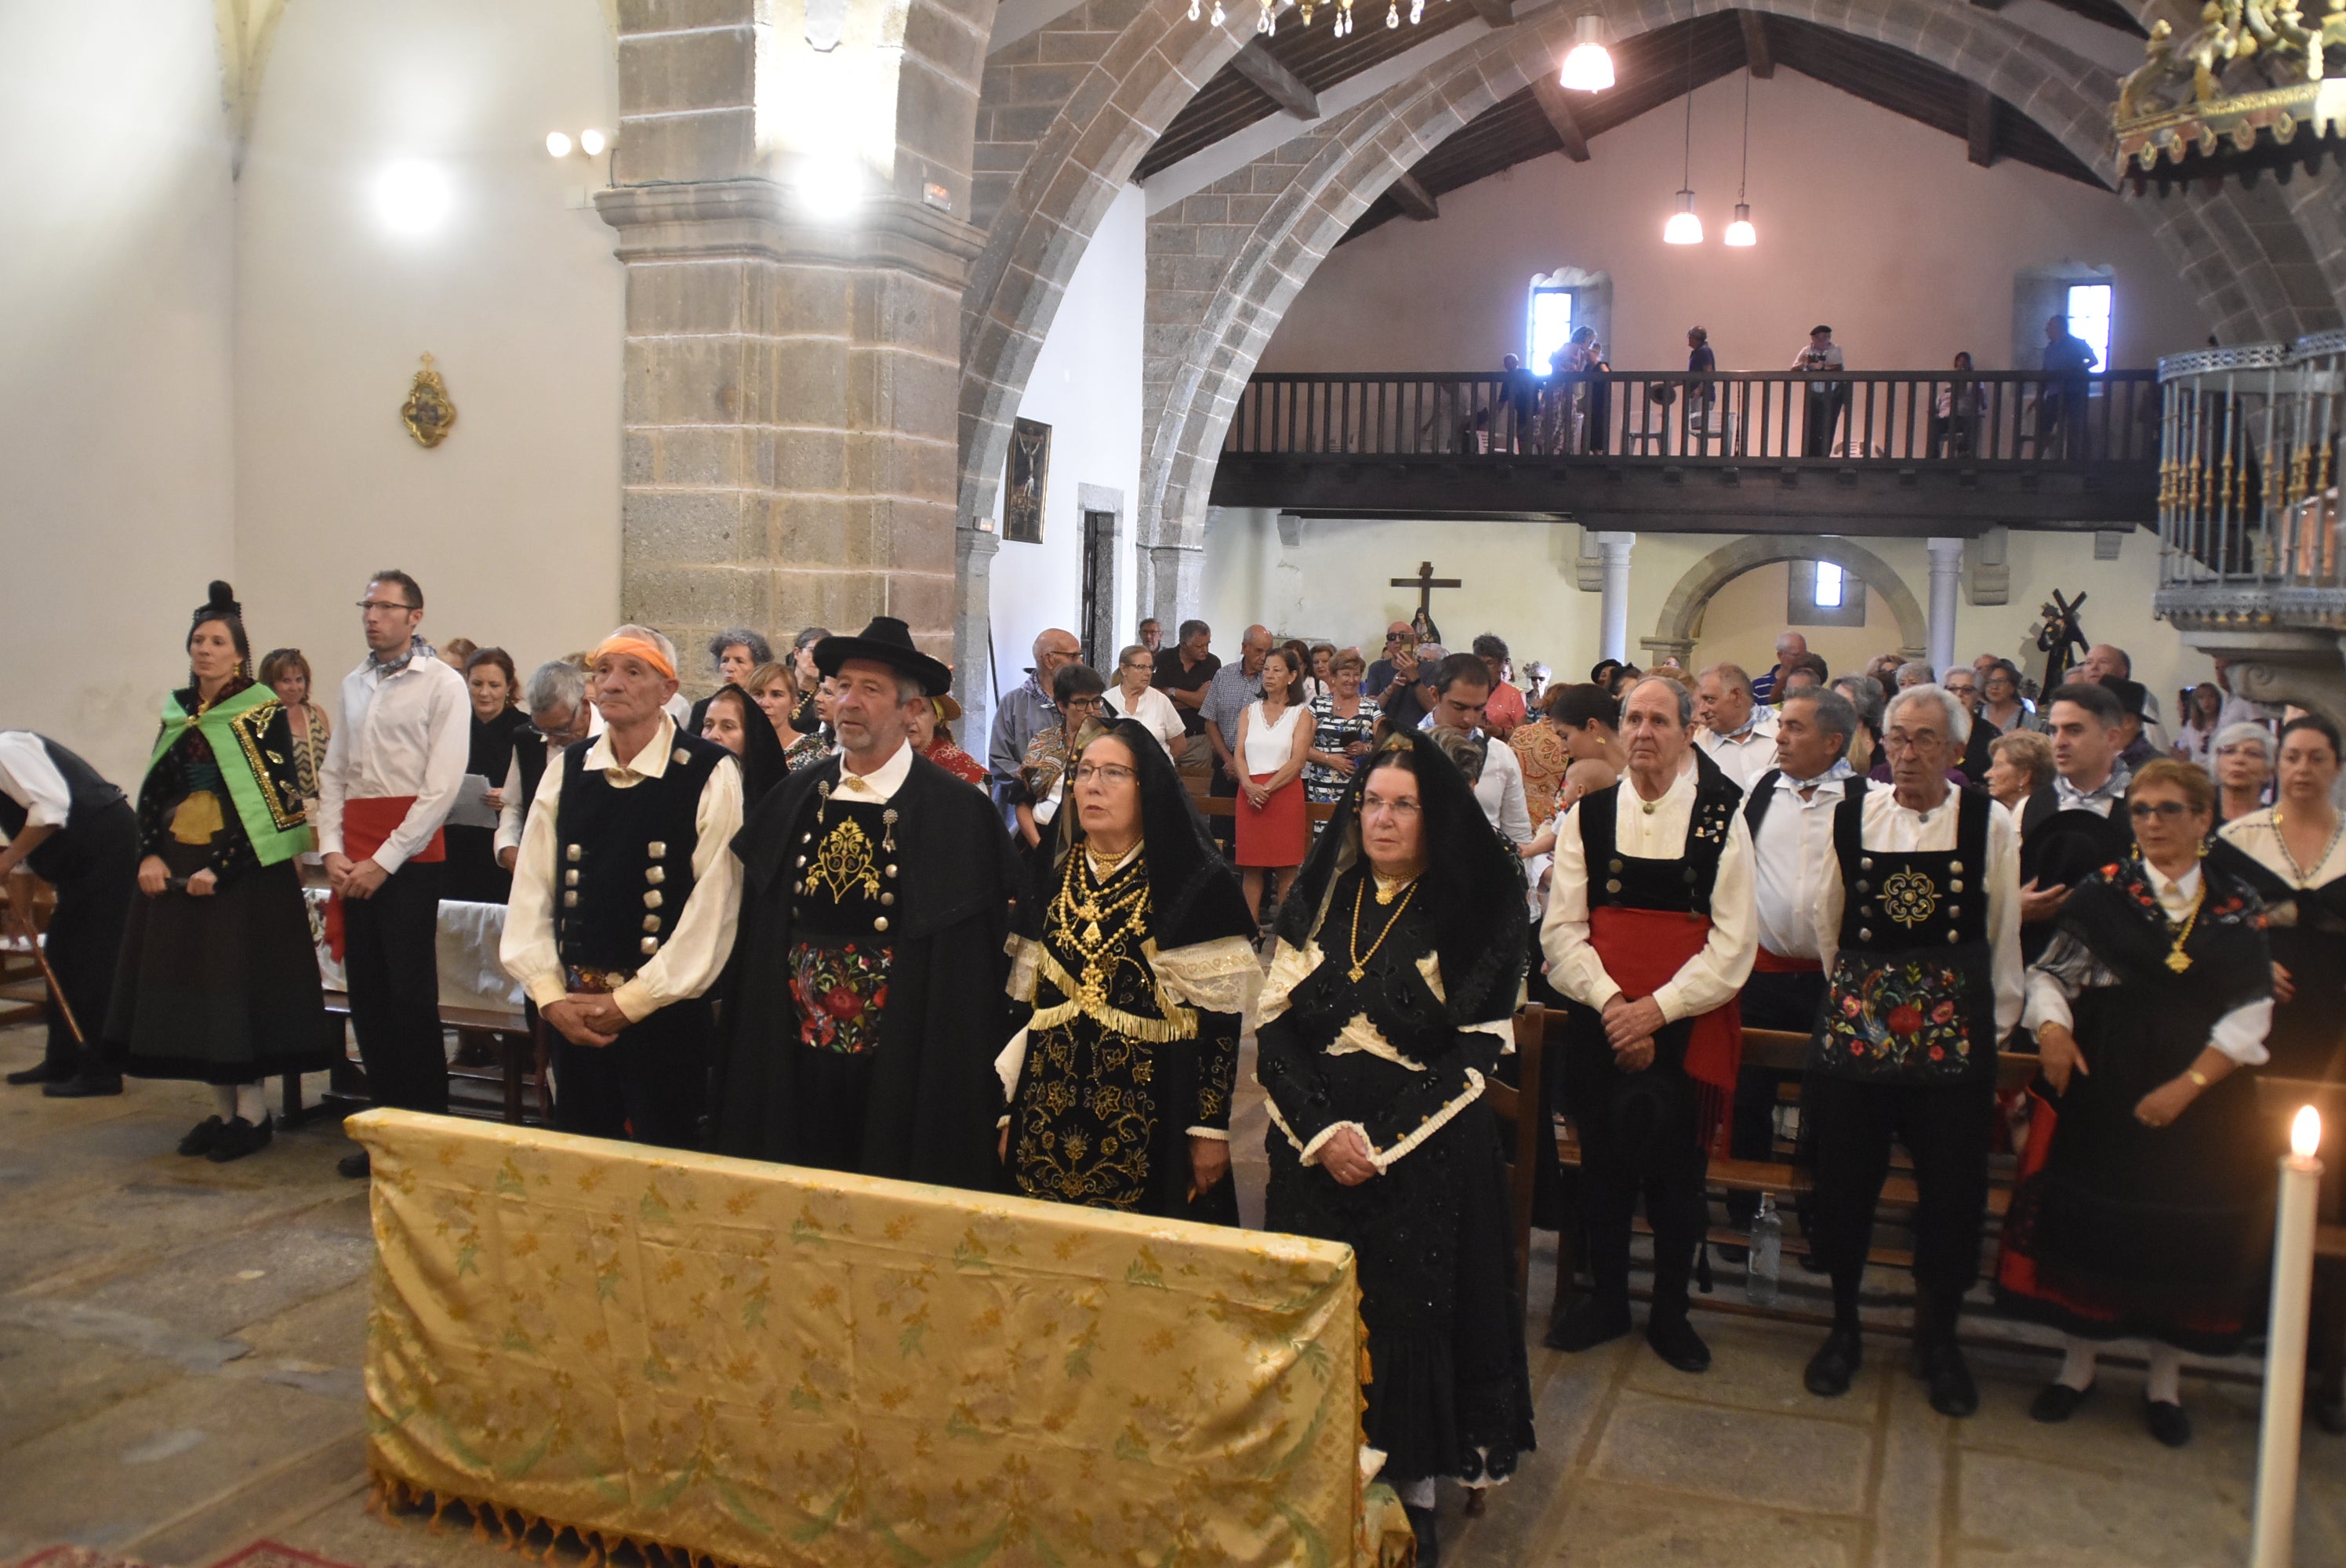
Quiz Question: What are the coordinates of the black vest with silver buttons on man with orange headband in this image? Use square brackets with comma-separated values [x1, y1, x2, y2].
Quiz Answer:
[554, 732, 732, 975]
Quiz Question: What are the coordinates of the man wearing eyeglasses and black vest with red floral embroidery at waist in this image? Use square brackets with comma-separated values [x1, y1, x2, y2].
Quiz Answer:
[1799, 683, 2022, 1415]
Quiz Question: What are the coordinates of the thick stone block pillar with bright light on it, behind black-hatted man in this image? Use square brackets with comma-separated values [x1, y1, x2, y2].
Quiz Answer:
[596, 0, 983, 690]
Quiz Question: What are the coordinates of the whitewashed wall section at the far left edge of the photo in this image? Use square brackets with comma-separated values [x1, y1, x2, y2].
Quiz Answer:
[0, 0, 234, 786]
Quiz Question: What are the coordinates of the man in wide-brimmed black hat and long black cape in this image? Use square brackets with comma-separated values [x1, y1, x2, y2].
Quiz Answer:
[716, 615, 1021, 1190]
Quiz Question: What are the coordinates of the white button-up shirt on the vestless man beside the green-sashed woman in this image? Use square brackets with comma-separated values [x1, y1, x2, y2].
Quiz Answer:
[317, 652, 471, 873]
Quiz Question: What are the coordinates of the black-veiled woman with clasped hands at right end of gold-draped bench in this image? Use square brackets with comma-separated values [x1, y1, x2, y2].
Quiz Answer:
[1255, 730, 1532, 1563]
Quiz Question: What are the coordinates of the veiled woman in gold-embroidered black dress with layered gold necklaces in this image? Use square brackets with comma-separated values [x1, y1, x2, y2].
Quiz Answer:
[997, 718, 1262, 1225]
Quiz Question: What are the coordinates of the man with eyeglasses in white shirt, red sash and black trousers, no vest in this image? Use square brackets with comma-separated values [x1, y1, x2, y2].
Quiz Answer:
[317, 571, 471, 1178]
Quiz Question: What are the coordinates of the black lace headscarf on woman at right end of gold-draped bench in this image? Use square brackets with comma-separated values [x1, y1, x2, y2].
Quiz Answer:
[1279, 730, 1530, 1025]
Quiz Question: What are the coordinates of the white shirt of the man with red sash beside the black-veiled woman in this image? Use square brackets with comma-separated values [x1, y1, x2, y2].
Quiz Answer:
[1539, 756, 1760, 1023]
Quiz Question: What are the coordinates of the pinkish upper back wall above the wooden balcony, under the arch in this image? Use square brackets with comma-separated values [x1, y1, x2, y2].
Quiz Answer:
[1262, 68, 2207, 371]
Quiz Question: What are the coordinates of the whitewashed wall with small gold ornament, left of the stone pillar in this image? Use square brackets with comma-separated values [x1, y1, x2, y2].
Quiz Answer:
[237, 0, 622, 692]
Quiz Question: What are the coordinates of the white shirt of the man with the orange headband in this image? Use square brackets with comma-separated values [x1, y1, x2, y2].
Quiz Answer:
[497, 713, 741, 1023]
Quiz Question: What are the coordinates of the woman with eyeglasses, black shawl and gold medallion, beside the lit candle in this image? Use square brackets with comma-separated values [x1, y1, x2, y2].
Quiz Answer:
[1996, 758, 2278, 1448]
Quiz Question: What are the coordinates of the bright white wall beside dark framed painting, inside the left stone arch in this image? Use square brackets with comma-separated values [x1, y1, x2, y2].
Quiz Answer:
[976, 186, 1147, 690]
